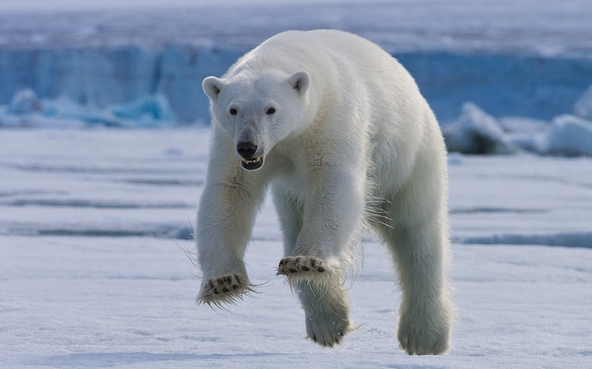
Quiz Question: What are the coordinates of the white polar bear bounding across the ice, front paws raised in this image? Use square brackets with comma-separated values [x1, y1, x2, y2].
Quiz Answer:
[196, 30, 453, 355]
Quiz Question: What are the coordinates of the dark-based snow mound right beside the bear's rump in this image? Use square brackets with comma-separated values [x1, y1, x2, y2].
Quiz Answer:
[442, 102, 513, 154]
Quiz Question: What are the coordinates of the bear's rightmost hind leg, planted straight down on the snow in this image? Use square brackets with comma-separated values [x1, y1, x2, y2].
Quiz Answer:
[376, 187, 454, 355]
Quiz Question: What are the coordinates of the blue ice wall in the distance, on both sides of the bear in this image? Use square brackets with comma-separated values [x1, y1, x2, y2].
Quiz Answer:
[0, 45, 592, 123]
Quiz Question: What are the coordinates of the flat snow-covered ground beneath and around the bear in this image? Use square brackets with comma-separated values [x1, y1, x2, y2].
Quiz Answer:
[0, 128, 592, 369]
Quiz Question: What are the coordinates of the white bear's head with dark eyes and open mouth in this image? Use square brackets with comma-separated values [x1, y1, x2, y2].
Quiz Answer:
[202, 71, 310, 170]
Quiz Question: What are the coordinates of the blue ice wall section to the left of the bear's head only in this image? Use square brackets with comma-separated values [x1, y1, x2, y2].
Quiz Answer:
[0, 46, 241, 122]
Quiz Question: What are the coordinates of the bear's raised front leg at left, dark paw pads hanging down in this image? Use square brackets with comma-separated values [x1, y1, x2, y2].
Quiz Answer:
[196, 148, 265, 307]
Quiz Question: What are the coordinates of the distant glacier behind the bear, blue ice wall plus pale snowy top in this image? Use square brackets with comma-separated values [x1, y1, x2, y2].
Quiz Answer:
[0, 0, 592, 126]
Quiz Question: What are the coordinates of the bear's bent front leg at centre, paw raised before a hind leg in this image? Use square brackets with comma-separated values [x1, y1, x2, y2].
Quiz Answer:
[276, 155, 366, 274]
